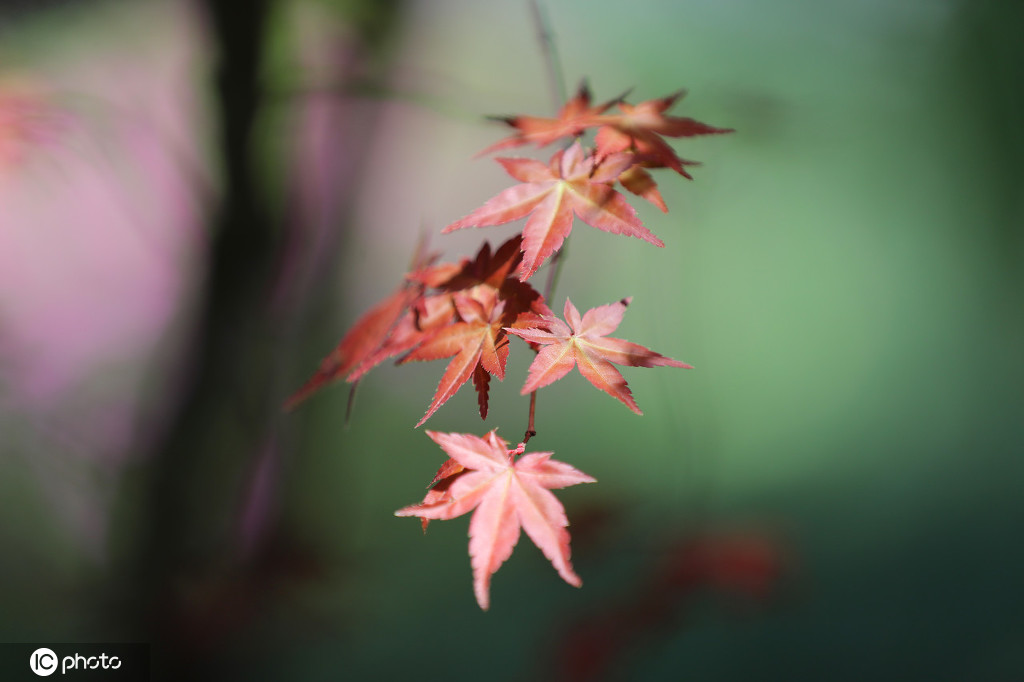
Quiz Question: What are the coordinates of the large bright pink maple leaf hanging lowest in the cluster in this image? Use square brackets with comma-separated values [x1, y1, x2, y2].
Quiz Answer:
[395, 431, 595, 610]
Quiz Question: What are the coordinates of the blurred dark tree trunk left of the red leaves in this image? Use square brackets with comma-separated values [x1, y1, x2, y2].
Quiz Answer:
[137, 0, 276, 680]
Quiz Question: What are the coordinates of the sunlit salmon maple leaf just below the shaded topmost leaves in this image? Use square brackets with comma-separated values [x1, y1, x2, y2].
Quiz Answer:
[441, 142, 665, 282]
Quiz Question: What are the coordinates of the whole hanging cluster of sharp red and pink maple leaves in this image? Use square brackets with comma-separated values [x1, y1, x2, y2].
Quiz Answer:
[287, 84, 731, 609]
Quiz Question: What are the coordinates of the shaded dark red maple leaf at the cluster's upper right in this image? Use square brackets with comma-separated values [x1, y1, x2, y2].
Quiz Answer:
[594, 90, 733, 179]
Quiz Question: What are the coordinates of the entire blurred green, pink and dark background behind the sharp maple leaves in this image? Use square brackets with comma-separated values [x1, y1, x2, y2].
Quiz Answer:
[0, 0, 1024, 681]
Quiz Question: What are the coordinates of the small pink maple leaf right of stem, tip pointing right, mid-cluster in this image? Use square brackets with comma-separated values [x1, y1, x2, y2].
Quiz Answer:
[506, 298, 693, 415]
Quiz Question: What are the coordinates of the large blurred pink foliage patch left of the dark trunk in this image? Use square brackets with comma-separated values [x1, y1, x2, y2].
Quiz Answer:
[0, 3, 212, 549]
